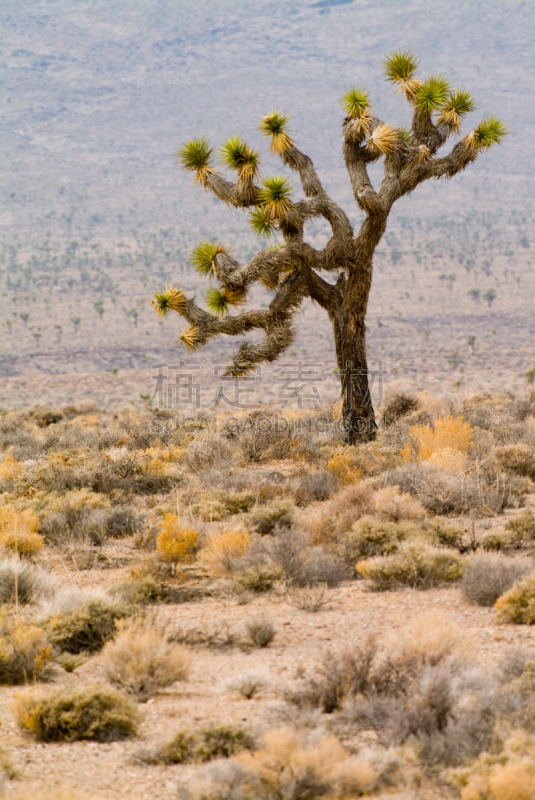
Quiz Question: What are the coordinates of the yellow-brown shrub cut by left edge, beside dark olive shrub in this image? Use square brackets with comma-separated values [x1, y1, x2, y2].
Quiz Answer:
[0, 614, 52, 685]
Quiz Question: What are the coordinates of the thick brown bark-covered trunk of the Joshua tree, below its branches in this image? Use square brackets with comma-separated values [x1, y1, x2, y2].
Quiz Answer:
[333, 265, 380, 444]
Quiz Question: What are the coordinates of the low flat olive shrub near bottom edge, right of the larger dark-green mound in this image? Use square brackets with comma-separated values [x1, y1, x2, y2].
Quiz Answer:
[161, 725, 256, 764]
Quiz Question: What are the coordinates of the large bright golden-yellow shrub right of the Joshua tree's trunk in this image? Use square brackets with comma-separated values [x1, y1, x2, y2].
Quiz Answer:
[408, 416, 472, 472]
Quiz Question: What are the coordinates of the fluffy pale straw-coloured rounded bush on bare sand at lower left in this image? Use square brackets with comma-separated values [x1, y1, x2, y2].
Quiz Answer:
[102, 620, 191, 700]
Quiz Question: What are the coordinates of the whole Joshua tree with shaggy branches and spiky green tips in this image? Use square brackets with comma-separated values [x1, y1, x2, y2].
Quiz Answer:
[153, 51, 505, 443]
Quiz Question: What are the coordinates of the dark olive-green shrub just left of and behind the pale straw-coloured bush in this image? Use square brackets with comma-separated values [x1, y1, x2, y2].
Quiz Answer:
[46, 595, 129, 653]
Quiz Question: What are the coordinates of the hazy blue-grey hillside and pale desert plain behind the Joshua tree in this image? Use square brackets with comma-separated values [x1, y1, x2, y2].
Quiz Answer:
[0, 0, 535, 406]
